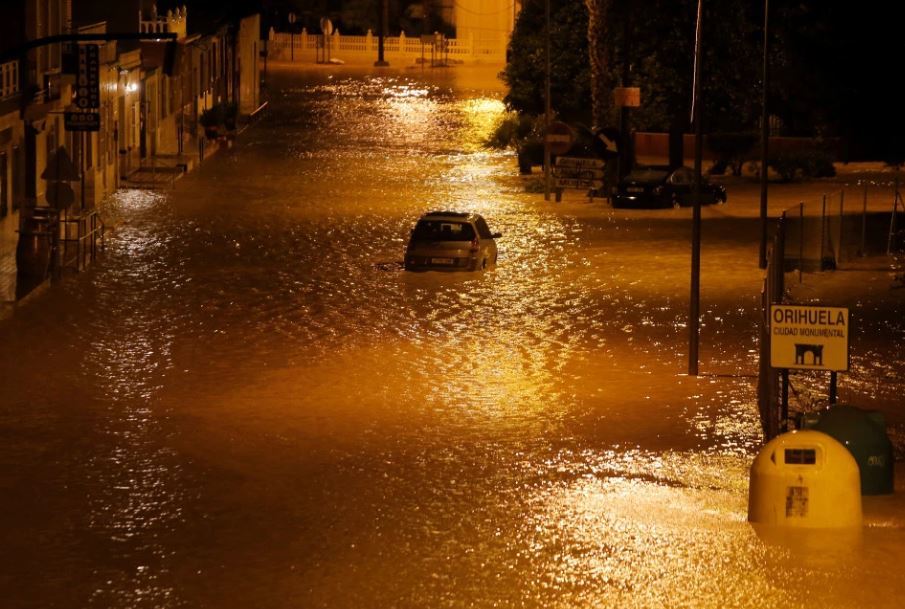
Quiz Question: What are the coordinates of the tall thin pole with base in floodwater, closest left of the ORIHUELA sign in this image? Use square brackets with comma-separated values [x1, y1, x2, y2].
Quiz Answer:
[688, 0, 704, 376]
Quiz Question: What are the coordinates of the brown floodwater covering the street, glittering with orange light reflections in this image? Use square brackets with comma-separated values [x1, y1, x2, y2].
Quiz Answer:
[0, 67, 905, 609]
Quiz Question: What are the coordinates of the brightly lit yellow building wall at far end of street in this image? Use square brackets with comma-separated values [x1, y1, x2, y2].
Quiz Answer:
[444, 0, 522, 54]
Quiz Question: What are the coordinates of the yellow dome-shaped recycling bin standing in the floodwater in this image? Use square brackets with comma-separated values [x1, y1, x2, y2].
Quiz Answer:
[748, 430, 862, 529]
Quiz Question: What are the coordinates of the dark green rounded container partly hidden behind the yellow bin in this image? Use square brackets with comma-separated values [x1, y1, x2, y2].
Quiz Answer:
[803, 404, 895, 495]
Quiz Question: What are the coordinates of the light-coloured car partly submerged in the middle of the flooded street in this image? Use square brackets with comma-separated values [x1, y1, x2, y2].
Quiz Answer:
[405, 211, 503, 271]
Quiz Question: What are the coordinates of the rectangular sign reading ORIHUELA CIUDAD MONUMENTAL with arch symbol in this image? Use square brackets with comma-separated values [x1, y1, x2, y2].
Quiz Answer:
[770, 305, 849, 371]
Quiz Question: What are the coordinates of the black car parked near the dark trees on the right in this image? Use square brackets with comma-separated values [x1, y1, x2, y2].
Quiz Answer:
[613, 165, 726, 208]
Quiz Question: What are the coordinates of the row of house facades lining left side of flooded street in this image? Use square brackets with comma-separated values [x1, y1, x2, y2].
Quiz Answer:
[0, 0, 260, 302]
